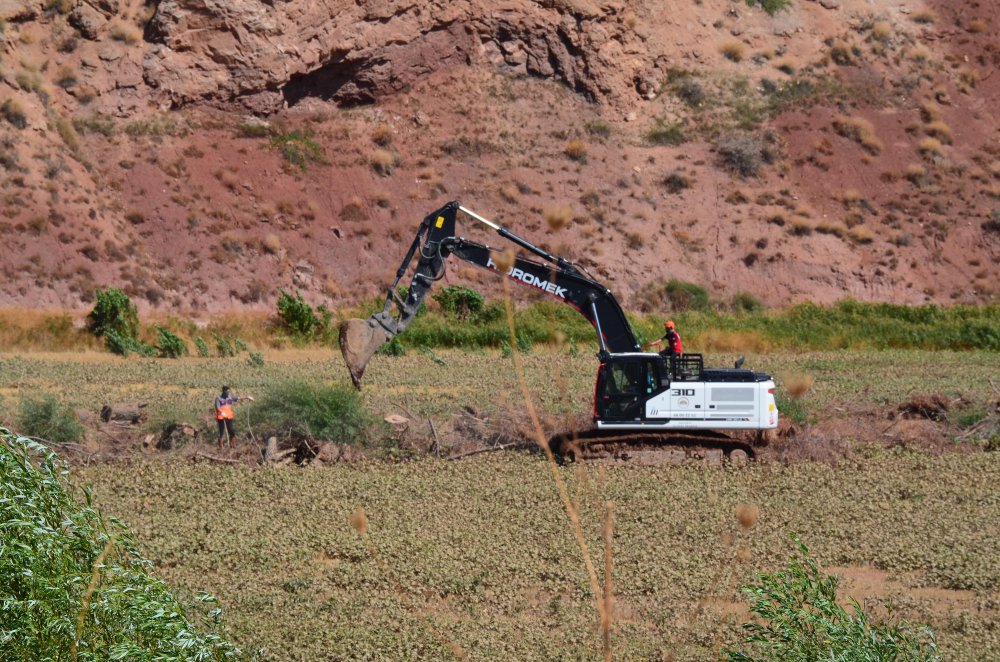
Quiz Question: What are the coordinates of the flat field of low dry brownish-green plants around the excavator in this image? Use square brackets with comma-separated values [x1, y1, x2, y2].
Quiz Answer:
[0, 348, 1000, 660]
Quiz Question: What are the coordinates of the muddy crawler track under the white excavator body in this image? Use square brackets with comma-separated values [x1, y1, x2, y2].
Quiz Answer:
[549, 428, 756, 466]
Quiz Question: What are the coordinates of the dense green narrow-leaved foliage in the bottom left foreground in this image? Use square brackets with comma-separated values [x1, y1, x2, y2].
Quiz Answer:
[0, 428, 239, 661]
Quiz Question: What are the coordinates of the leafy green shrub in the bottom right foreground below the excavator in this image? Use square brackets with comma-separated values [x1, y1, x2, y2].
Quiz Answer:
[725, 535, 941, 662]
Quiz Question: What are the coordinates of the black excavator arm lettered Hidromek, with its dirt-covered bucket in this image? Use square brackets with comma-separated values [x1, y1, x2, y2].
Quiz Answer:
[340, 201, 639, 388]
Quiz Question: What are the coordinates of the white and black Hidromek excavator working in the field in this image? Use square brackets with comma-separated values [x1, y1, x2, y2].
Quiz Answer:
[339, 201, 778, 459]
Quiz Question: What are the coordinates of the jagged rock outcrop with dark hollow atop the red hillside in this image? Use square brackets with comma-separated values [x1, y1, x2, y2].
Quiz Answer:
[144, 0, 653, 111]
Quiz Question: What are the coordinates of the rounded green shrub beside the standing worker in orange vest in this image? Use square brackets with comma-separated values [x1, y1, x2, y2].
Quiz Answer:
[254, 381, 374, 445]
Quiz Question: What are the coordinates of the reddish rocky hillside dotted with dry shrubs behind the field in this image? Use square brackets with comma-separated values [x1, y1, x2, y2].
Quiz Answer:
[0, 0, 1000, 311]
